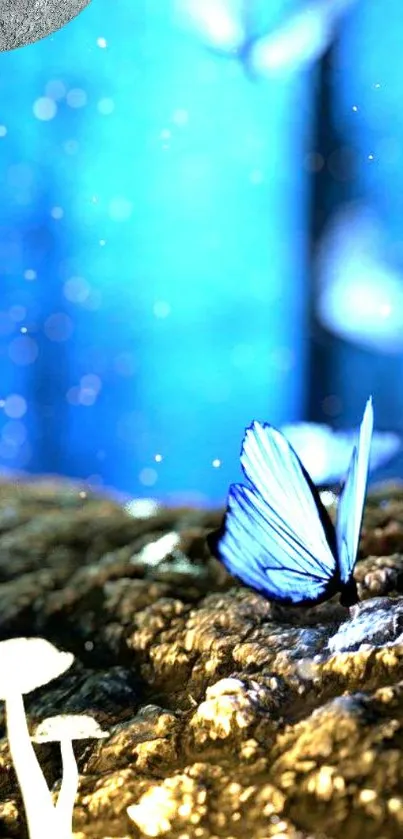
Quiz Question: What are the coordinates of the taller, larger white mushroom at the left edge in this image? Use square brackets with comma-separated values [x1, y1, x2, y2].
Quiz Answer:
[0, 638, 74, 839]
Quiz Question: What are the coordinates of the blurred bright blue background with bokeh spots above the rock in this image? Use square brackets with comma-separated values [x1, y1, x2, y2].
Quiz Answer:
[0, 0, 403, 503]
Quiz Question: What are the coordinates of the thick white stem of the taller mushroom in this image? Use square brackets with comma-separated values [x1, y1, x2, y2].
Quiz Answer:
[5, 691, 57, 839]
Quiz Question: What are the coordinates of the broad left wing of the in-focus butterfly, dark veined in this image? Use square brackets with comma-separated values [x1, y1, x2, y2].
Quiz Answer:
[210, 422, 337, 603]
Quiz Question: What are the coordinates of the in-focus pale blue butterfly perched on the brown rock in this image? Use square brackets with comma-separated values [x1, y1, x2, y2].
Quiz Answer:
[208, 398, 374, 606]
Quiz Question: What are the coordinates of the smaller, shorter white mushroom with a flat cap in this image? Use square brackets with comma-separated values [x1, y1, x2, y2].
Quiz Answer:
[32, 714, 109, 837]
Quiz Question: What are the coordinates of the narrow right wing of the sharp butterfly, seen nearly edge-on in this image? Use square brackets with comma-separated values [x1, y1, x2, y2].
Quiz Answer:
[336, 398, 374, 583]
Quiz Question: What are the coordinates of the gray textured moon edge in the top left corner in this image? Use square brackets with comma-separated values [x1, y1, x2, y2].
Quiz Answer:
[0, 0, 91, 52]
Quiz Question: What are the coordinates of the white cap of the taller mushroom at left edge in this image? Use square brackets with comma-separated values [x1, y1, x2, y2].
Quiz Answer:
[0, 638, 74, 699]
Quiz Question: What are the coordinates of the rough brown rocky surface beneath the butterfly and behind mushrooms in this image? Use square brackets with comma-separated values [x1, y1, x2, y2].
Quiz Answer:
[0, 480, 403, 839]
